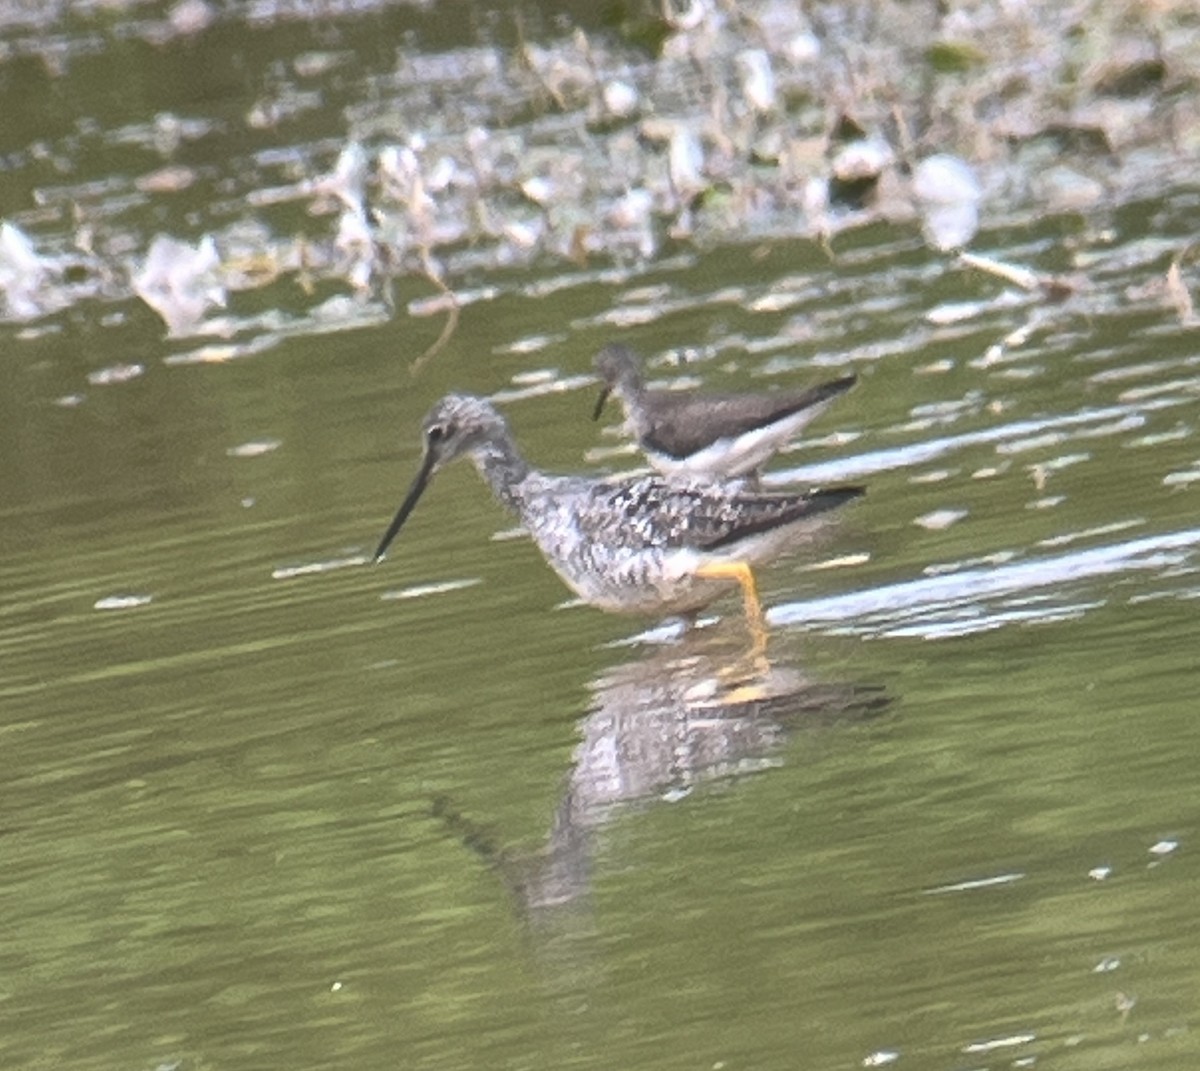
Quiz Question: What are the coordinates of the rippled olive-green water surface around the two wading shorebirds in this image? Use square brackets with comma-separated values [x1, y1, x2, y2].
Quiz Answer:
[0, 6, 1200, 1071]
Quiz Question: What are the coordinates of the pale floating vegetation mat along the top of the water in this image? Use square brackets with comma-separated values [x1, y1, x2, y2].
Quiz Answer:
[0, 0, 1200, 365]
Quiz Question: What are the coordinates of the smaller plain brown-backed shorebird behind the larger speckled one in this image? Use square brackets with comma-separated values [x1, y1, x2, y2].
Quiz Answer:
[592, 345, 856, 479]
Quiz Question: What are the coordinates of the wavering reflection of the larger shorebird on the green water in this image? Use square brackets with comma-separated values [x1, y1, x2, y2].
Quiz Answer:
[434, 633, 888, 928]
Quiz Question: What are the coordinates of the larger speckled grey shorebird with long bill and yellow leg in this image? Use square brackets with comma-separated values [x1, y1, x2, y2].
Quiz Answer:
[374, 394, 863, 654]
